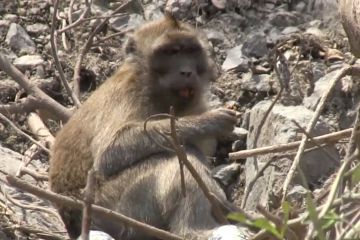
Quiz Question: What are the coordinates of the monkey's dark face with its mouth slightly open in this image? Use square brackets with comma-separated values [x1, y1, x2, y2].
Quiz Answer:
[148, 33, 212, 113]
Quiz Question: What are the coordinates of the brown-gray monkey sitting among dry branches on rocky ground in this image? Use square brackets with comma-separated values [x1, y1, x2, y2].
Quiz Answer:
[49, 15, 237, 239]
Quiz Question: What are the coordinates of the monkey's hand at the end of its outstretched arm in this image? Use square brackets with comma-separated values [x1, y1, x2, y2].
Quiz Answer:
[200, 108, 237, 137]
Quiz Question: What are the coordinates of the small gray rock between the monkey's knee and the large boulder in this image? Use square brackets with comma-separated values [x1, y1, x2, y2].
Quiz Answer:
[211, 163, 240, 186]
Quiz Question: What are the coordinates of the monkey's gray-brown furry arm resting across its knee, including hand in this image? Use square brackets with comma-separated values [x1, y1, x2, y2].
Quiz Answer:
[96, 109, 236, 177]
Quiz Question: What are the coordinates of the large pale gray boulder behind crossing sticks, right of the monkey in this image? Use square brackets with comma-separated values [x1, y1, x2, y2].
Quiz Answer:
[245, 100, 340, 210]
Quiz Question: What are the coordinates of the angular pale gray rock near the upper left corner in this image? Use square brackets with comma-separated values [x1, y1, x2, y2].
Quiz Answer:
[5, 23, 36, 54]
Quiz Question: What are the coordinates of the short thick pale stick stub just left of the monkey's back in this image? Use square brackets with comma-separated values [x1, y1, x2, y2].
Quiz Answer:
[27, 113, 55, 148]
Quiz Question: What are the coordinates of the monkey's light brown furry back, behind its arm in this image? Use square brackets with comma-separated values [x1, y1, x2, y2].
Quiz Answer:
[49, 64, 142, 196]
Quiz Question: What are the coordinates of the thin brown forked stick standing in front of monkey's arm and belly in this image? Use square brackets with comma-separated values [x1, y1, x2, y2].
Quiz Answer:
[170, 107, 229, 224]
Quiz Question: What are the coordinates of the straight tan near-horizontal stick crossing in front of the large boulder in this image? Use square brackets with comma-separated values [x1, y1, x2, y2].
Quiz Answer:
[229, 128, 352, 160]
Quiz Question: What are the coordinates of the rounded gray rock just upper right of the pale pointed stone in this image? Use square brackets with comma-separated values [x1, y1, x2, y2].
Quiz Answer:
[241, 33, 268, 58]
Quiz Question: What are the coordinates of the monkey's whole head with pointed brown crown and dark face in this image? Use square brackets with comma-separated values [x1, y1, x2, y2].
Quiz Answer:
[125, 15, 215, 114]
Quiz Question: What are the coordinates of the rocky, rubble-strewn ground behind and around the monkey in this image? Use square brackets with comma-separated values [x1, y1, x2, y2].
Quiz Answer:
[0, 0, 359, 240]
